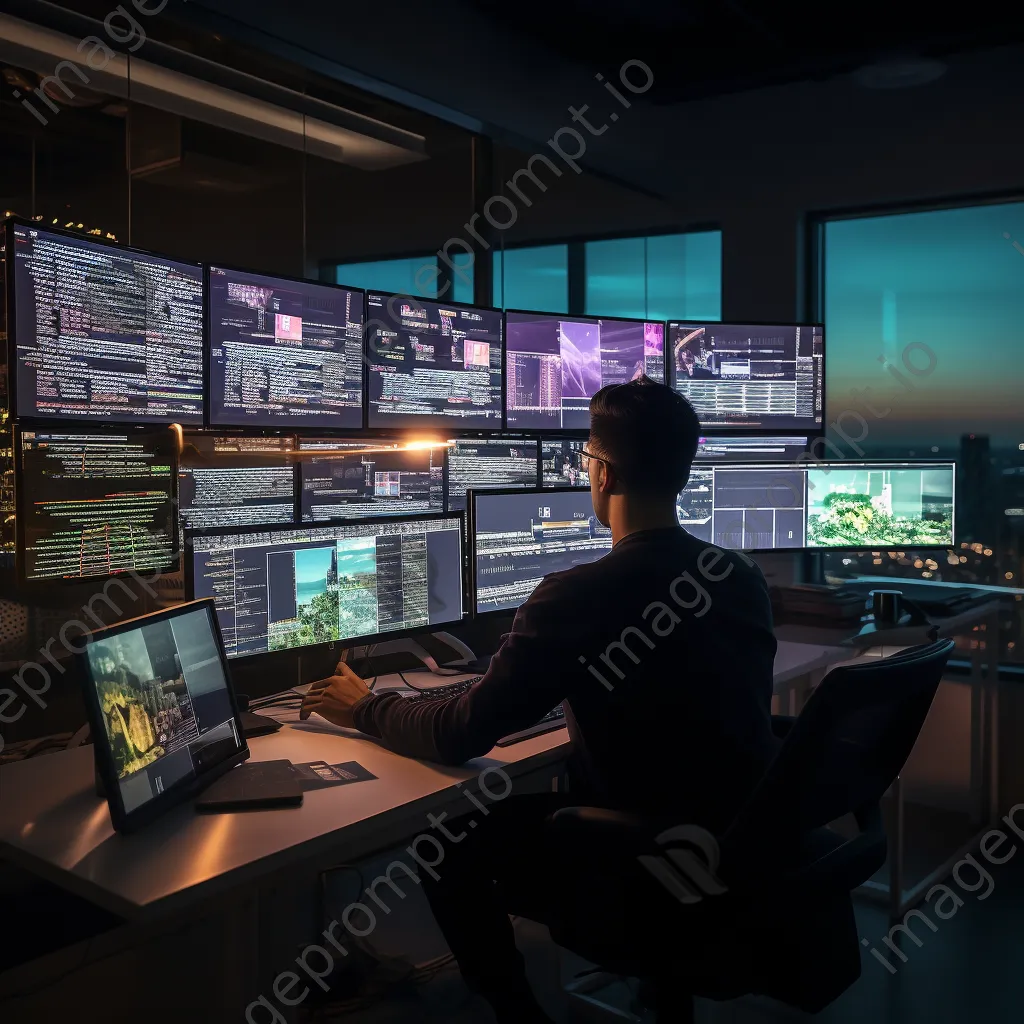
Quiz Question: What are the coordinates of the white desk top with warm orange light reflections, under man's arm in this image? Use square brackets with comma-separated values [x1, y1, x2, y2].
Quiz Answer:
[0, 642, 850, 916]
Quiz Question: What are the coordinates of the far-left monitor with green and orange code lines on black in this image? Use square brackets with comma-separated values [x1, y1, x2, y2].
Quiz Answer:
[15, 427, 178, 581]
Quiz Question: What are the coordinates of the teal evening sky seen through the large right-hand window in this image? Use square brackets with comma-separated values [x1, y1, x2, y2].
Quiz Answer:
[824, 203, 1024, 454]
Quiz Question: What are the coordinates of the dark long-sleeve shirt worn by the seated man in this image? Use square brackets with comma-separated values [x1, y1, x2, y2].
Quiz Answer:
[354, 528, 776, 827]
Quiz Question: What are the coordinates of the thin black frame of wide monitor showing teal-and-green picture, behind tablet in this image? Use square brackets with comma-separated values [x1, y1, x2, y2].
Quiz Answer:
[182, 512, 468, 662]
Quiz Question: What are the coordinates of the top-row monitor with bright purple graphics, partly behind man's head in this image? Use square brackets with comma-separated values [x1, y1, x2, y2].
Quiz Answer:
[505, 310, 665, 430]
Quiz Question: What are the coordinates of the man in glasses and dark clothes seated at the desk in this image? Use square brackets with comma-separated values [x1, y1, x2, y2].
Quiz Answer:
[302, 378, 775, 1024]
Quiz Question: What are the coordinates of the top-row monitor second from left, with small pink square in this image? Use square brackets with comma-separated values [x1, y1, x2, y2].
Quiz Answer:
[209, 266, 365, 430]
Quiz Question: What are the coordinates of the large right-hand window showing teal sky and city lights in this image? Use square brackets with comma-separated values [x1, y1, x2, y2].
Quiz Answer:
[820, 202, 1024, 662]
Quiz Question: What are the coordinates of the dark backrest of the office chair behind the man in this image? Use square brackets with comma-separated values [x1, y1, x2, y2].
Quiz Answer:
[722, 639, 953, 866]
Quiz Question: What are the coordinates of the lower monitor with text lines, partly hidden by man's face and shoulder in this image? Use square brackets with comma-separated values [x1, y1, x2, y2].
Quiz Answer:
[469, 488, 611, 615]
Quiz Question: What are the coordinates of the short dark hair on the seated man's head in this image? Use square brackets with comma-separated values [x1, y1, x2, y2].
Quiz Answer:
[590, 377, 700, 496]
